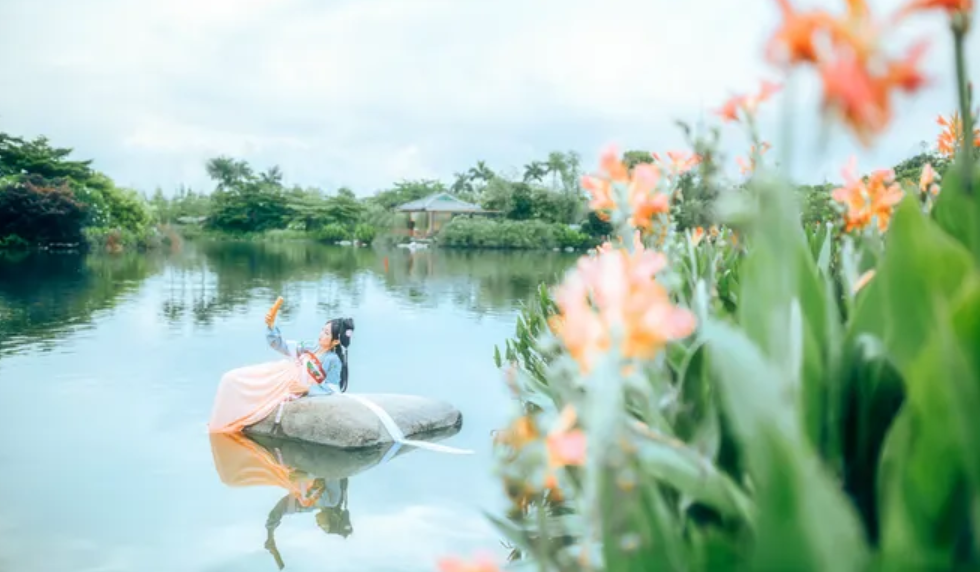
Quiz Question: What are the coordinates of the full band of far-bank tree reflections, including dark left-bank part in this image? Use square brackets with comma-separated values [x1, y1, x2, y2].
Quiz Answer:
[0, 242, 575, 355]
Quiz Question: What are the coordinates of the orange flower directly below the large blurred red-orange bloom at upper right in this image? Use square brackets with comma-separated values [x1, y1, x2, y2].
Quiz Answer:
[832, 158, 902, 232]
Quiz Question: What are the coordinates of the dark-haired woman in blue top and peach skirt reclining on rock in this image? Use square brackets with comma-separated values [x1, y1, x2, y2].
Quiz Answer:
[208, 297, 354, 433]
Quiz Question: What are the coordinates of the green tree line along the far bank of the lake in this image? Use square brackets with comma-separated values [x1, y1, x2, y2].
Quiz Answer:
[0, 127, 944, 249]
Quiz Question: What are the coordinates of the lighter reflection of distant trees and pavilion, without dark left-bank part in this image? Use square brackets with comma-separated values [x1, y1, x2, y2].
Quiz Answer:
[163, 239, 575, 325]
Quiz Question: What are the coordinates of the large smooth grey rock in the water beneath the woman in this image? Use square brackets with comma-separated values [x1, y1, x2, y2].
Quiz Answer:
[245, 393, 463, 450]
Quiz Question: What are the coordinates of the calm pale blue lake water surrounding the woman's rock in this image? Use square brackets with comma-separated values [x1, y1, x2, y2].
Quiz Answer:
[0, 243, 574, 572]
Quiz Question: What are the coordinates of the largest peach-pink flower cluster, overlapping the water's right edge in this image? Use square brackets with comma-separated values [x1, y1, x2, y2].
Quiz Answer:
[555, 236, 695, 372]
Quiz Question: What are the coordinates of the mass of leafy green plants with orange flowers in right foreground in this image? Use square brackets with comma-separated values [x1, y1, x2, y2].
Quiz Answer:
[441, 2, 980, 572]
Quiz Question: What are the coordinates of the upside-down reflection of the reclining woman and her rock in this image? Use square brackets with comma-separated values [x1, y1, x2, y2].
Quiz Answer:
[209, 420, 459, 570]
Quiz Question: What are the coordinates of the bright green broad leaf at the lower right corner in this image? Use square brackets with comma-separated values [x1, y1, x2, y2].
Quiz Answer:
[881, 275, 980, 569]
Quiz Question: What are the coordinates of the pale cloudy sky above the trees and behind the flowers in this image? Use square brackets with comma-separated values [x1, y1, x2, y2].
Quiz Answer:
[0, 0, 980, 196]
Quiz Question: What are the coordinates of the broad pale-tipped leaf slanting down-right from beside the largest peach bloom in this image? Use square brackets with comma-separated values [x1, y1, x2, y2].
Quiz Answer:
[705, 322, 868, 572]
